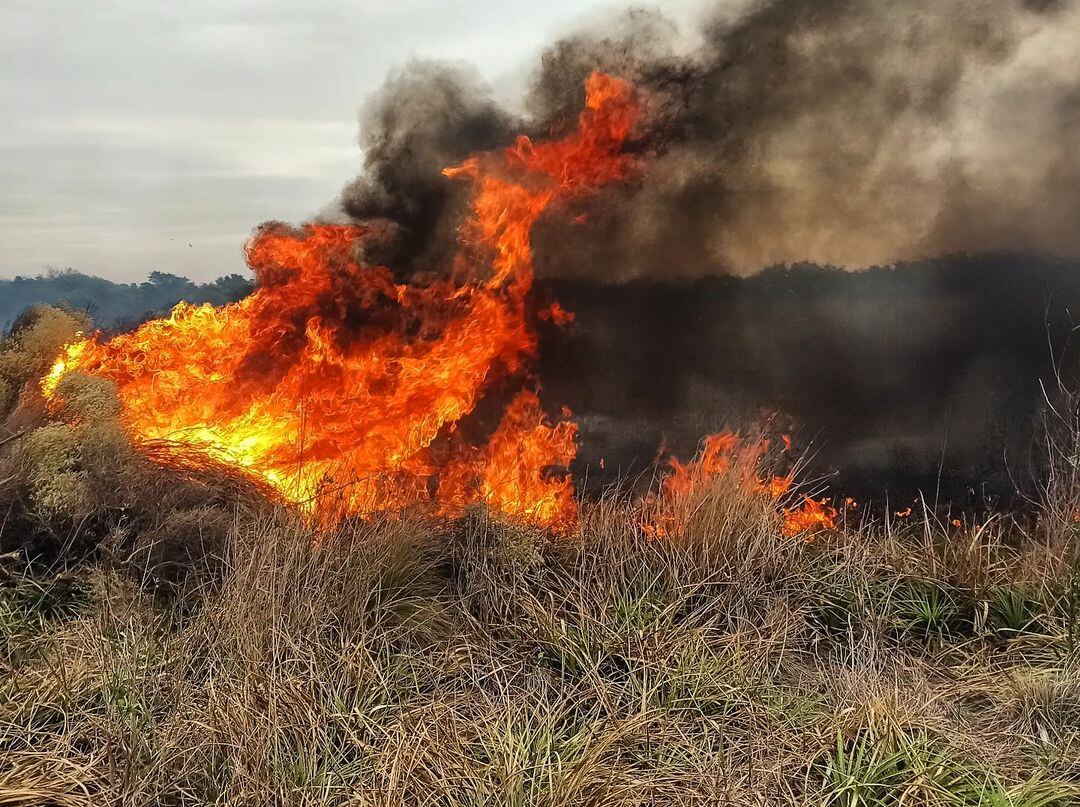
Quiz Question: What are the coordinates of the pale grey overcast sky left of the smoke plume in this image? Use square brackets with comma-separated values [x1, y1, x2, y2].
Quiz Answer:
[0, 0, 708, 281]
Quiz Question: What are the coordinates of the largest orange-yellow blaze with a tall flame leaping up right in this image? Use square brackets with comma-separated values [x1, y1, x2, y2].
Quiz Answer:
[42, 73, 639, 529]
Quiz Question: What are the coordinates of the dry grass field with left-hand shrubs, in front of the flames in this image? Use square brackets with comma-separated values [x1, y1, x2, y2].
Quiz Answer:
[0, 312, 1080, 807]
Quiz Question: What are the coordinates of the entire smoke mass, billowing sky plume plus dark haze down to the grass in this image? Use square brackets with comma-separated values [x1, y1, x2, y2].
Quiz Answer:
[332, 0, 1080, 500]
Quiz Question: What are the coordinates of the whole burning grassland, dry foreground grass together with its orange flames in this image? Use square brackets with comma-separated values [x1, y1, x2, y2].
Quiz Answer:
[0, 61, 1080, 807]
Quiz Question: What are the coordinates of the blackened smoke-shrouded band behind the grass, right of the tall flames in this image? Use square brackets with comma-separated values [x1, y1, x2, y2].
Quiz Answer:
[538, 254, 1080, 506]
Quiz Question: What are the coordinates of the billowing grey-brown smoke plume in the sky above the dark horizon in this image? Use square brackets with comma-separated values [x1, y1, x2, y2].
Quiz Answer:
[343, 0, 1080, 281]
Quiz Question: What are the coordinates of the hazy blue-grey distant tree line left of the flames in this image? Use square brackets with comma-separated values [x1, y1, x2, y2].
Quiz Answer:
[0, 269, 253, 333]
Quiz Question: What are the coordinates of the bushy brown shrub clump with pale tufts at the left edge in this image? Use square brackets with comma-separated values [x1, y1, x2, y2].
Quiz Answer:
[0, 308, 270, 584]
